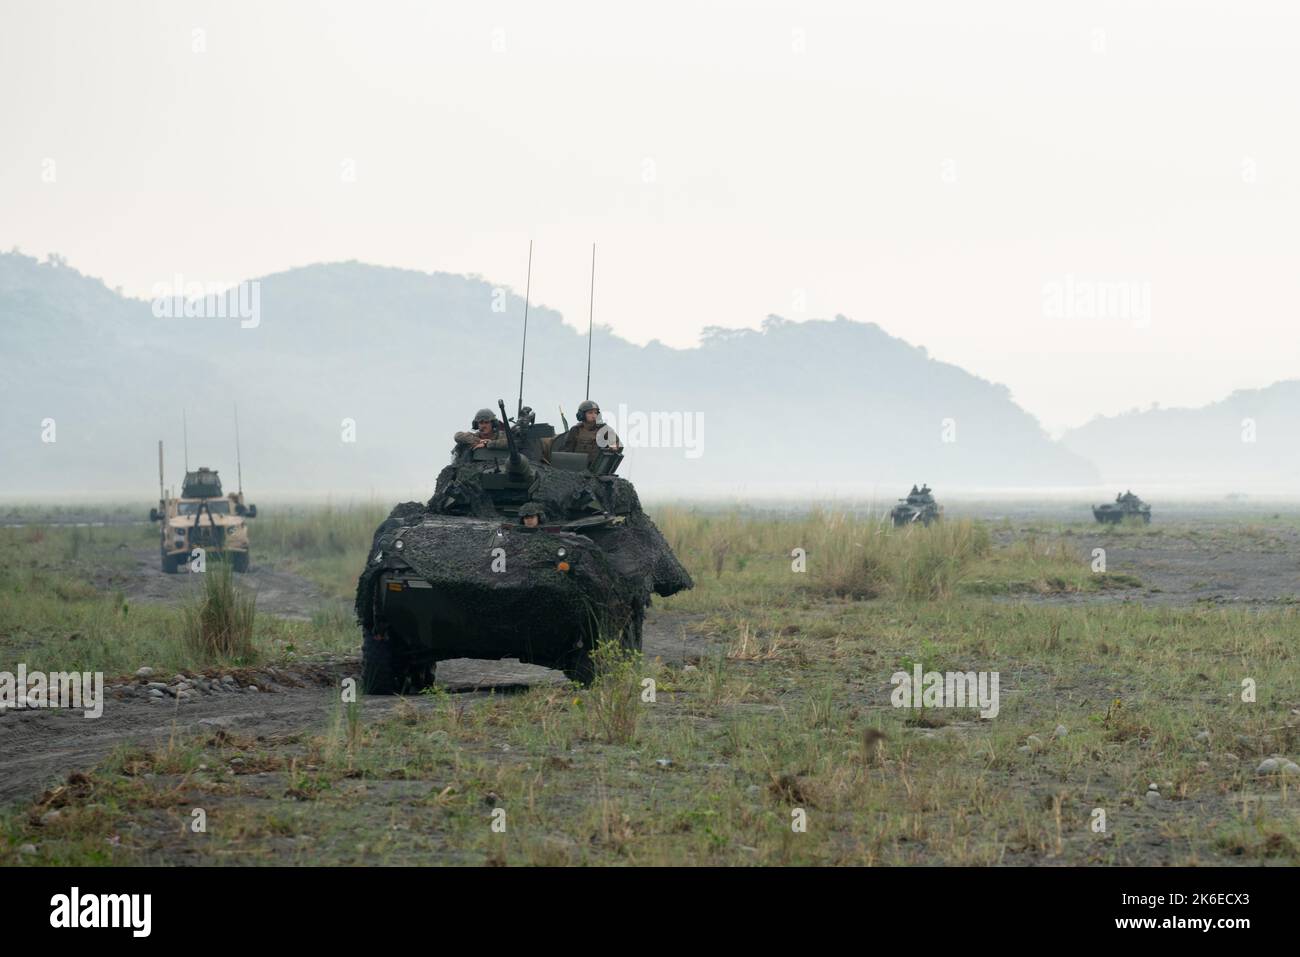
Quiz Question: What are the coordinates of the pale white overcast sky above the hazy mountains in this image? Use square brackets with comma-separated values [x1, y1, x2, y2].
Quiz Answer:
[0, 0, 1300, 432]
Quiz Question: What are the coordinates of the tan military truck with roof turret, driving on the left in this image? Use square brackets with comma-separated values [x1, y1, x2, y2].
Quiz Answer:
[150, 442, 257, 575]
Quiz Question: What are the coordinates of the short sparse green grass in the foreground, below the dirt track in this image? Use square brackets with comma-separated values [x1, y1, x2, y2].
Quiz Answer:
[0, 599, 1300, 865]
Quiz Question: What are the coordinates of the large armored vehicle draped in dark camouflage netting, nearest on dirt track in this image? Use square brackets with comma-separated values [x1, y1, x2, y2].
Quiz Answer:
[356, 400, 694, 693]
